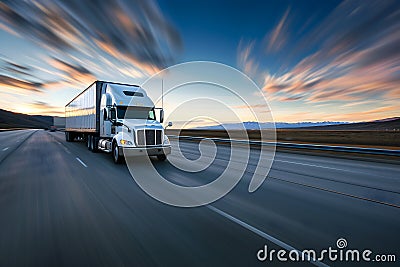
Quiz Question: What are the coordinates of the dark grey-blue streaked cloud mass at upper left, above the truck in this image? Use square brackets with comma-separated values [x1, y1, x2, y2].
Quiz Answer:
[0, 0, 181, 68]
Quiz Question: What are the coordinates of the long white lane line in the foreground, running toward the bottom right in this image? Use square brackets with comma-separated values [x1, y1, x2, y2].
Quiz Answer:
[206, 205, 329, 267]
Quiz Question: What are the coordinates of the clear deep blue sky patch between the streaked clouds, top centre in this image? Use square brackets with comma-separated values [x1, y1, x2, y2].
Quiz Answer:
[159, 0, 340, 69]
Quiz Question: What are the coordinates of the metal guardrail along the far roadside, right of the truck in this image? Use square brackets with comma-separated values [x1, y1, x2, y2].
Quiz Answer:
[168, 135, 400, 157]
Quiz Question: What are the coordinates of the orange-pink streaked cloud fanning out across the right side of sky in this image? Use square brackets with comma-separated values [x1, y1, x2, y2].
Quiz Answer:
[238, 1, 400, 118]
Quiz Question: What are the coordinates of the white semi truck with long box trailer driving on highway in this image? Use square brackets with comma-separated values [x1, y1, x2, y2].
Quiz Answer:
[65, 81, 172, 163]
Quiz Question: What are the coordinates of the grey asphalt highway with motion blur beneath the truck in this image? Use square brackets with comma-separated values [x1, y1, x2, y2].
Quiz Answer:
[0, 130, 400, 266]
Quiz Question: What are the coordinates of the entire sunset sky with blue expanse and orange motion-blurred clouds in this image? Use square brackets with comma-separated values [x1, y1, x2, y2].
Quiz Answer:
[0, 0, 400, 122]
